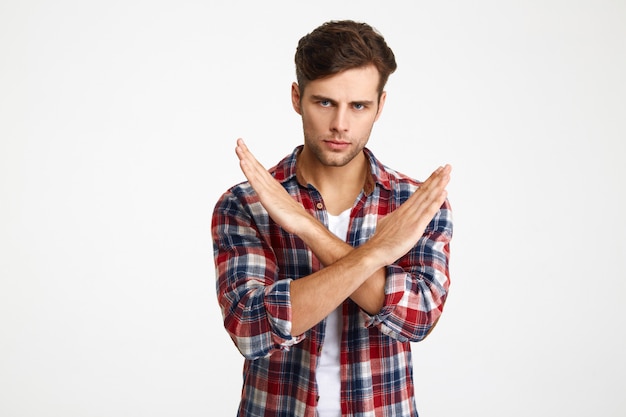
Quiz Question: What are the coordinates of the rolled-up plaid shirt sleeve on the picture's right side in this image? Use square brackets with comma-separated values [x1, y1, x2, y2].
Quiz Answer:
[363, 200, 452, 342]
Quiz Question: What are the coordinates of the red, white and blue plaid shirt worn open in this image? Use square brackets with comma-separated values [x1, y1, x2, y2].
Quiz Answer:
[212, 146, 452, 417]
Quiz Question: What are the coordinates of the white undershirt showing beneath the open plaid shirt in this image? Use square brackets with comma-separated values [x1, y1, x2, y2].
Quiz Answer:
[316, 209, 351, 417]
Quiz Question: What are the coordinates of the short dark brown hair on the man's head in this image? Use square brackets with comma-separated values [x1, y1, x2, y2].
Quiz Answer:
[295, 20, 397, 96]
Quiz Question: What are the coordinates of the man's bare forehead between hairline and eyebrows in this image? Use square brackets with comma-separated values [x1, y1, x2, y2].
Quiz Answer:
[305, 65, 380, 101]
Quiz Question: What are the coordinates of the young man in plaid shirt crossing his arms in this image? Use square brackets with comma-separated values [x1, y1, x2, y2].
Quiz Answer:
[212, 21, 452, 417]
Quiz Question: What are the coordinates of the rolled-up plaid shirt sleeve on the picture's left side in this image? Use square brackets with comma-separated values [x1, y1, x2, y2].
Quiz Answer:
[211, 192, 304, 359]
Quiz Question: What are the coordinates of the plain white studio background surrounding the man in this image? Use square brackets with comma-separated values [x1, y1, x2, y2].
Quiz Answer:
[0, 0, 626, 417]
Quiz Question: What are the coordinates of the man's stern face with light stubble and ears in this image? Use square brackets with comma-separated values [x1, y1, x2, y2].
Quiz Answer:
[292, 65, 385, 167]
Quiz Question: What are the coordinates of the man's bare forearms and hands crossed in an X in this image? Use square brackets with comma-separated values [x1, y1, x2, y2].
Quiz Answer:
[236, 139, 451, 335]
